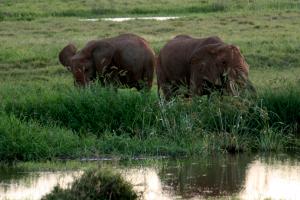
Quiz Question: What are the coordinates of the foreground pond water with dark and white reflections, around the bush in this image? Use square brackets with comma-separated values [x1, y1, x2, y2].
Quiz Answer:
[0, 154, 300, 200]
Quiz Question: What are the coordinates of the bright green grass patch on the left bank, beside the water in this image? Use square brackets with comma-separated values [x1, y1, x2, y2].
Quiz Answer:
[0, 113, 94, 162]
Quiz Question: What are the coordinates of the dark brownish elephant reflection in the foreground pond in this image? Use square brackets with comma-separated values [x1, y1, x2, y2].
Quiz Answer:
[160, 155, 253, 198]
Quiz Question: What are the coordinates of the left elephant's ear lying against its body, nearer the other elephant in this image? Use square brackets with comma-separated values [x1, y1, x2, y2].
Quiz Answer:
[92, 41, 115, 74]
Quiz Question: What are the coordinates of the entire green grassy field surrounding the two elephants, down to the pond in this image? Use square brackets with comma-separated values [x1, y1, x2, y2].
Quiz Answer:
[0, 0, 300, 161]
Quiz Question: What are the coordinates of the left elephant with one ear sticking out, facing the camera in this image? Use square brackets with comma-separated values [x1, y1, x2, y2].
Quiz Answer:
[58, 34, 156, 90]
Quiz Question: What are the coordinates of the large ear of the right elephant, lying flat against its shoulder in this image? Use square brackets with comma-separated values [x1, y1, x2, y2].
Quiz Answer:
[190, 43, 223, 93]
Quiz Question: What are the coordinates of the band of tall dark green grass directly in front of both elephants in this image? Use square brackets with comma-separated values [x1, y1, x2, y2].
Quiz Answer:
[2, 84, 300, 137]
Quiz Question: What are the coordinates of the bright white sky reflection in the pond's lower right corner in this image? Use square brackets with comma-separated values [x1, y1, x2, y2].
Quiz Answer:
[240, 160, 300, 199]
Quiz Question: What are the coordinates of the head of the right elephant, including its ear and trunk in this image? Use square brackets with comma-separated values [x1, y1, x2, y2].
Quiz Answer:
[190, 43, 254, 95]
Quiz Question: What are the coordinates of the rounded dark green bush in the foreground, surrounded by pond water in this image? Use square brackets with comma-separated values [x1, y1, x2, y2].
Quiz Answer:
[42, 169, 138, 200]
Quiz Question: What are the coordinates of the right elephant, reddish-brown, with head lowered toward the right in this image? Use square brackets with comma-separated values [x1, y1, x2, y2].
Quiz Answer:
[156, 35, 255, 99]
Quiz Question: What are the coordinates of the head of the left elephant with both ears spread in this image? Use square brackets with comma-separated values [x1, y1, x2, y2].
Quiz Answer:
[59, 41, 115, 86]
